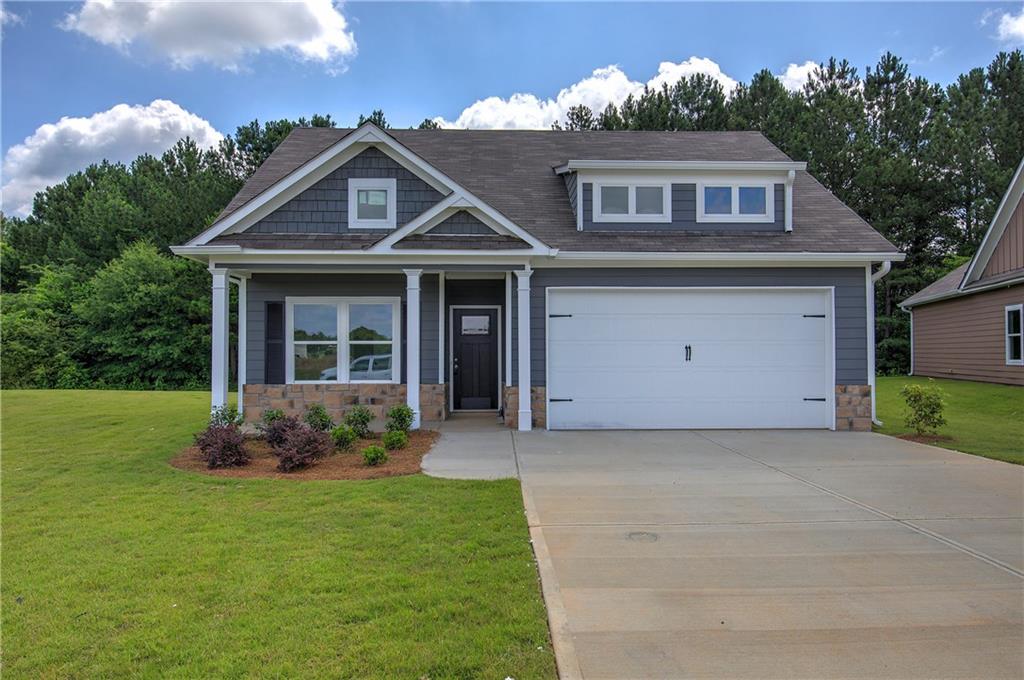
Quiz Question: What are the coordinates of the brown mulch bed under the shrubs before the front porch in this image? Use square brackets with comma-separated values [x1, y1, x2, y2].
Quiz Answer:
[171, 430, 438, 479]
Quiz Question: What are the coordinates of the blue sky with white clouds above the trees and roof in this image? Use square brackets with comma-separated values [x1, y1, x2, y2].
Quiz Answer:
[0, 0, 1024, 211]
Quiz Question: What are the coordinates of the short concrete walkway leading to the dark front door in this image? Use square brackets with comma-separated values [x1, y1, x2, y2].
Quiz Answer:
[422, 413, 519, 479]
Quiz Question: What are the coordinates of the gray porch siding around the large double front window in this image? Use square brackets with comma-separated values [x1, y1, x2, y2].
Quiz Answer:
[246, 273, 438, 384]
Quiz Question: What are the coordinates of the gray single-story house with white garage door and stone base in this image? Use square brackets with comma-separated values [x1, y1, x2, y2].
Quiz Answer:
[173, 124, 902, 430]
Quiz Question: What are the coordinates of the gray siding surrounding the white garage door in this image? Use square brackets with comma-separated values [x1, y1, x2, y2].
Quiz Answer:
[512, 267, 867, 385]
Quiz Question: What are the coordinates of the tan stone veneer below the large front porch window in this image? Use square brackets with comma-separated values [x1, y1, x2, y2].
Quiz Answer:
[243, 383, 447, 423]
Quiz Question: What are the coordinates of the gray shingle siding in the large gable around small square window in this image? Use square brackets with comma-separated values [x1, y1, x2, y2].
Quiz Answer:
[246, 148, 443, 233]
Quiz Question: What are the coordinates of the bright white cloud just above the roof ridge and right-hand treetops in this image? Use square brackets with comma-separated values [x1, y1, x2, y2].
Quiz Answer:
[434, 56, 736, 129]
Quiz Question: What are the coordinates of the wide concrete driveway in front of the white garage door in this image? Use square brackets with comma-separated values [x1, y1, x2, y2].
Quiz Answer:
[514, 431, 1024, 678]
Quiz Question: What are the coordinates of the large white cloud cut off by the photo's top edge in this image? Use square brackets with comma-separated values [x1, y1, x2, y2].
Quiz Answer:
[61, 0, 356, 73]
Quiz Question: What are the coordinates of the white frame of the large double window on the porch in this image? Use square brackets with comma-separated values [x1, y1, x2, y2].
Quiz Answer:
[285, 297, 401, 385]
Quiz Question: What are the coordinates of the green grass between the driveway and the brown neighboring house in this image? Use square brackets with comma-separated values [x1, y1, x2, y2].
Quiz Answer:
[876, 377, 1024, 465]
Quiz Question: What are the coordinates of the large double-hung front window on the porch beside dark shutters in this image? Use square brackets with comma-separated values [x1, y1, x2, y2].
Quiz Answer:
[286, 298, 401, 383]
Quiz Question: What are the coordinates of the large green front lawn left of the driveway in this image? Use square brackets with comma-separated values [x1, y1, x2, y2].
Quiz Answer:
[2, 391, 555, 680]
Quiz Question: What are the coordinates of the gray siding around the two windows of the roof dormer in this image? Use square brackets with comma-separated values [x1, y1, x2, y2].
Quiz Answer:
[573, 182, 785, 231]
